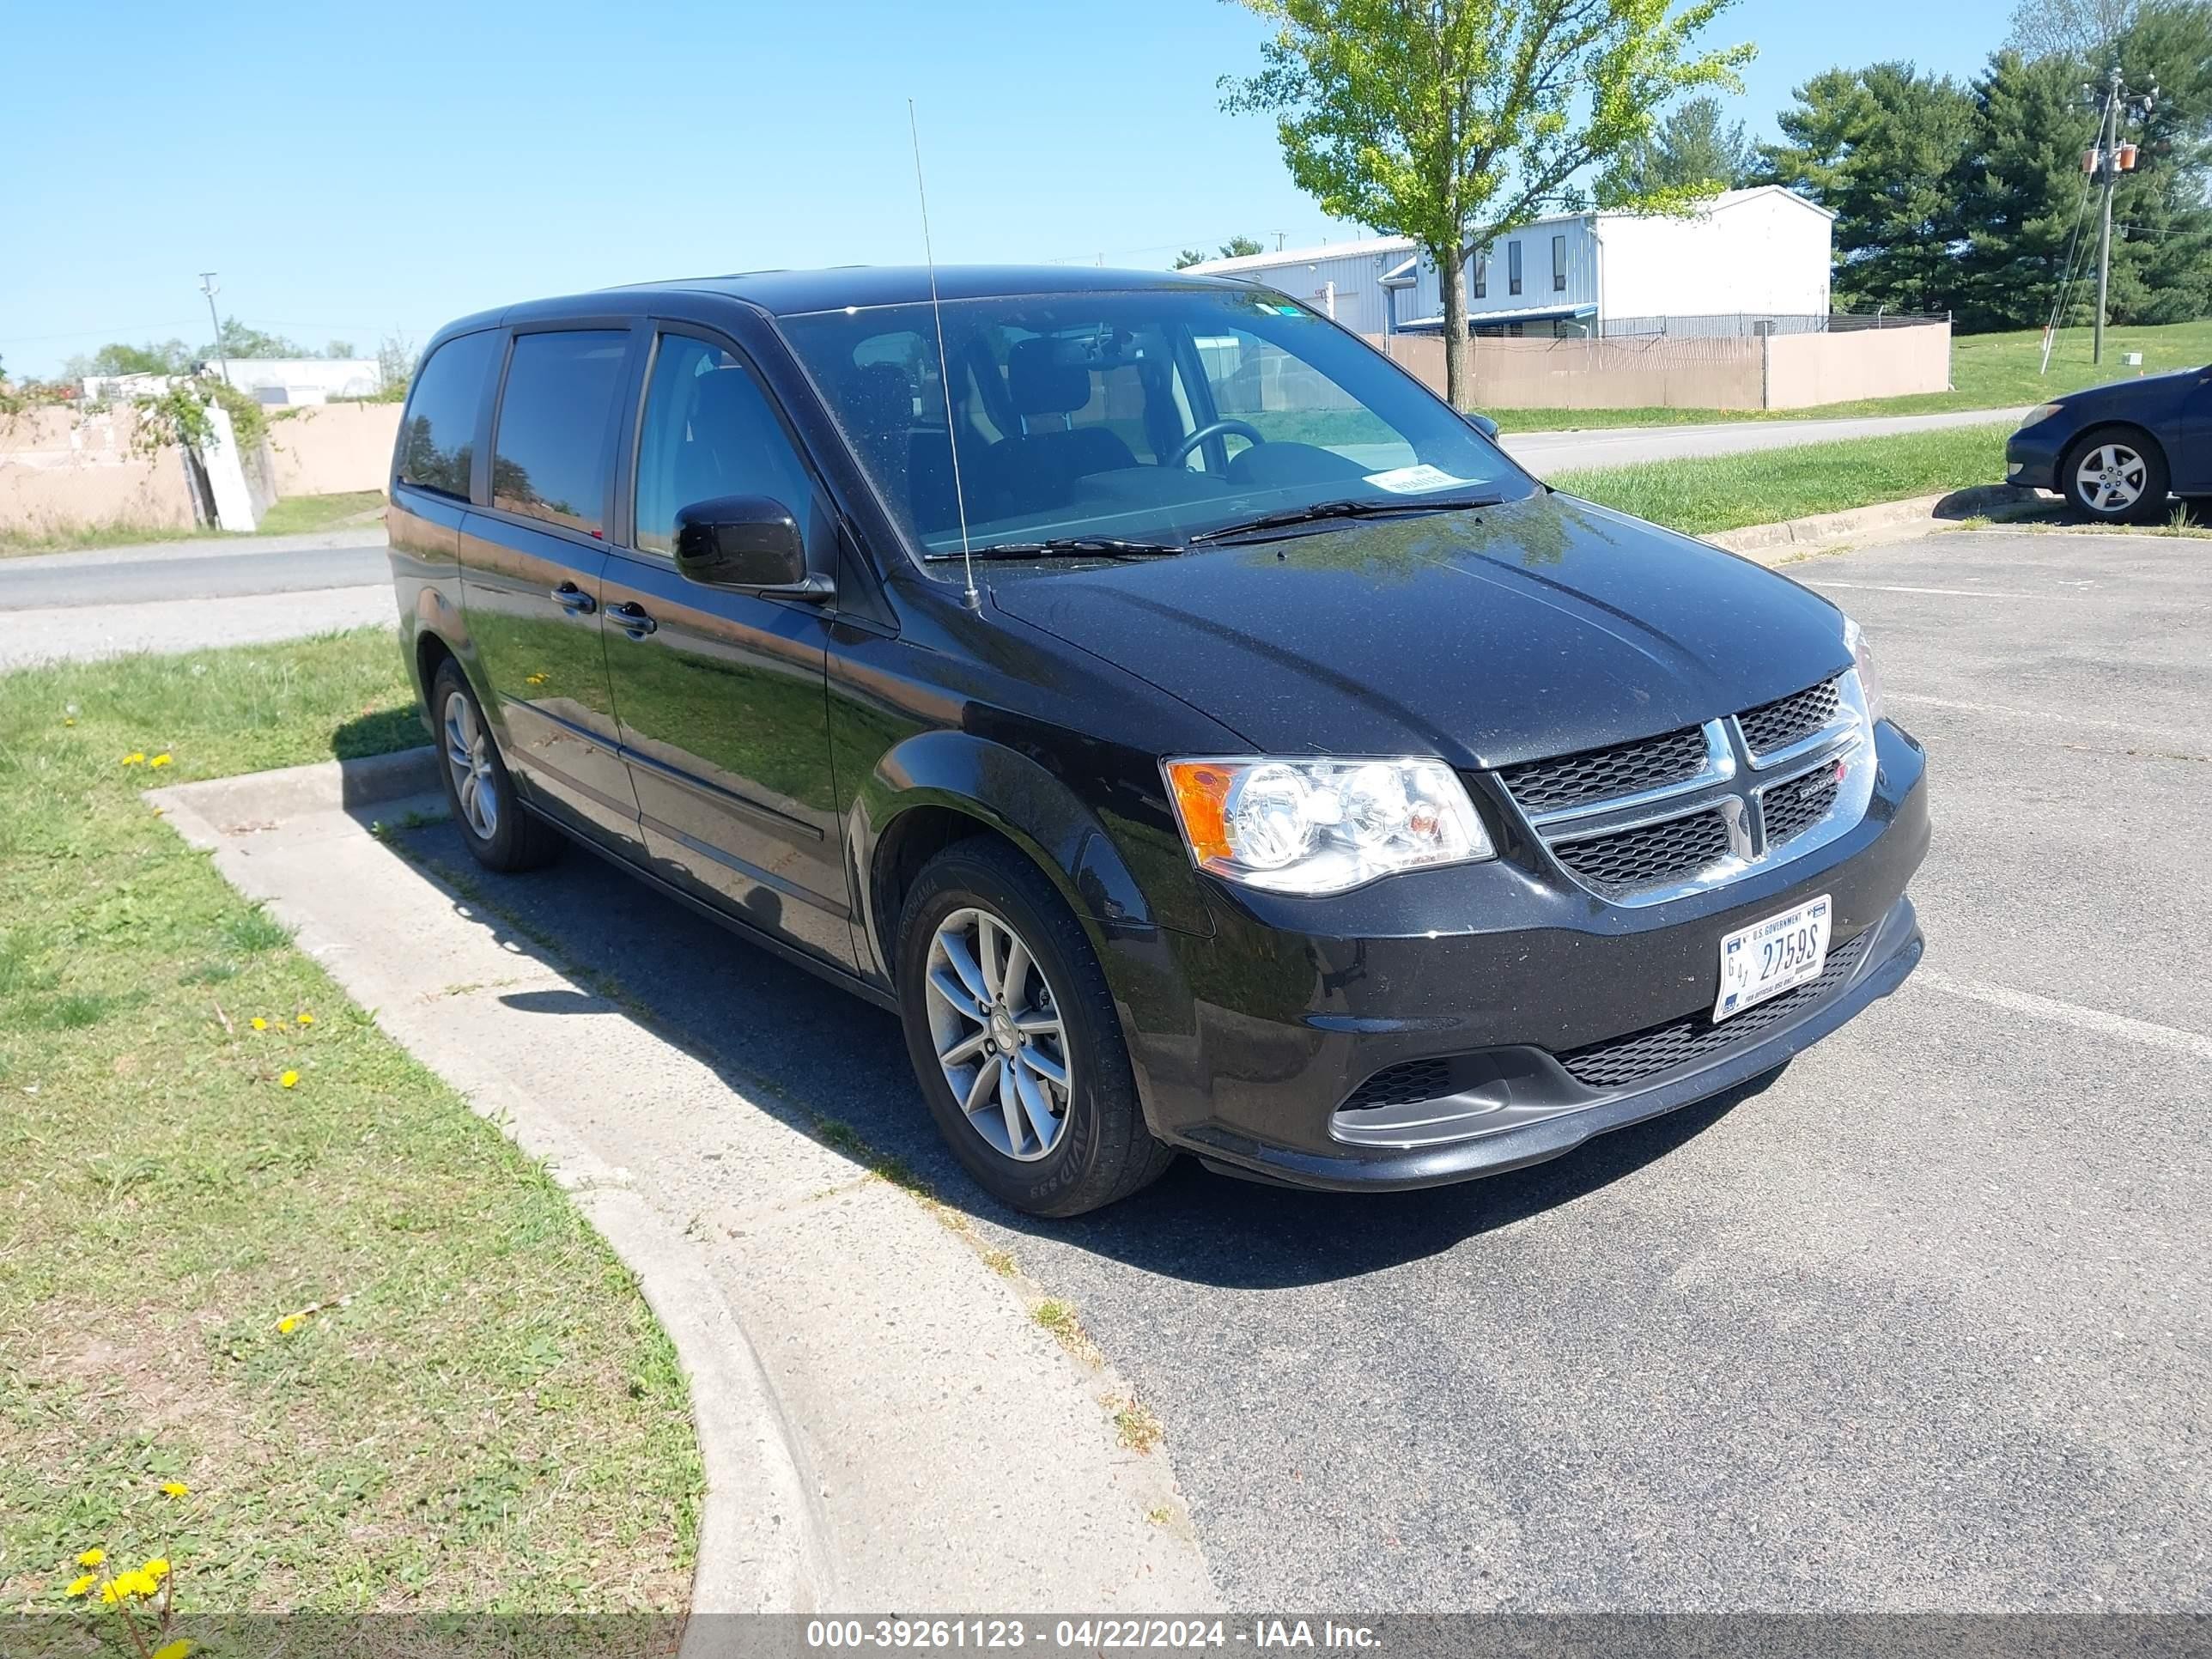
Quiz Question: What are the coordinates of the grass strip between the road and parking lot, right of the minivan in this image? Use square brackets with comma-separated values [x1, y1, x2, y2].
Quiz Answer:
[1548, 425, 2011, 535]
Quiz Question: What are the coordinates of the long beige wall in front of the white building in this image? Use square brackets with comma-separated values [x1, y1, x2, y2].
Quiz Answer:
[1370, 323, 1951, 410]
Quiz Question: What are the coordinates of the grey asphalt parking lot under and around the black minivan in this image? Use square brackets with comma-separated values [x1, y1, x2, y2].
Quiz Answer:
[410, 531, 2212, 1610]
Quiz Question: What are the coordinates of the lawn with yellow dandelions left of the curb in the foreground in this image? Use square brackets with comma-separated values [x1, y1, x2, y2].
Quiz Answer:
[0, 629, 702, 1650]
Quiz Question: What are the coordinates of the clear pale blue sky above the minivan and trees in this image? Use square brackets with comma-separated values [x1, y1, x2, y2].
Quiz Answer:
[0, 0, 2008, 374]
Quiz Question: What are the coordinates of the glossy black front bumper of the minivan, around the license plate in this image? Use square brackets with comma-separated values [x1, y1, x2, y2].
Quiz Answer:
[1109, 723, 1929, 1190]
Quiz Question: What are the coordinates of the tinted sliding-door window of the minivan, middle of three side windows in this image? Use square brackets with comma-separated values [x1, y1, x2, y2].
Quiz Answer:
[491, 330, 630, 535]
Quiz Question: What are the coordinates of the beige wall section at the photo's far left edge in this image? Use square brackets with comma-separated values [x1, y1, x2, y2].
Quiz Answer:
[0, 410, 195, 535]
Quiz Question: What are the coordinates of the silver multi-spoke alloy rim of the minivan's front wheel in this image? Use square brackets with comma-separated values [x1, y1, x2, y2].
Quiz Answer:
[927, 909, 1075, 1164]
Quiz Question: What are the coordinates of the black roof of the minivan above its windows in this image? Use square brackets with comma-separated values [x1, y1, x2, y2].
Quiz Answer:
[445, 265, 1234, 331]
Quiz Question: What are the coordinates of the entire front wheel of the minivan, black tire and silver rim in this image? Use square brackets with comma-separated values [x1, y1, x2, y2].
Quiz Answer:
[898, 838, 1175, 1217]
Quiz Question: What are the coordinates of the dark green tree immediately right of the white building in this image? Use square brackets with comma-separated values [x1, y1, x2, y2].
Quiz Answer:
[1760, 64, 1980, 312]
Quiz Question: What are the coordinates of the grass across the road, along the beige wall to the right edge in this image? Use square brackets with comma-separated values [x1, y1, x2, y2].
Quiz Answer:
[1484, 319, 2212, 434]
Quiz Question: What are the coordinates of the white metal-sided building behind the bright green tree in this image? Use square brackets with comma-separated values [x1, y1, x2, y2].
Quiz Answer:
[1190, 184, 1836, 334]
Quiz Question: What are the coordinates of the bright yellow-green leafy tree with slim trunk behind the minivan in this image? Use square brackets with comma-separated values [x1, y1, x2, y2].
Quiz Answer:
[1224, 0, 1754, 407]
